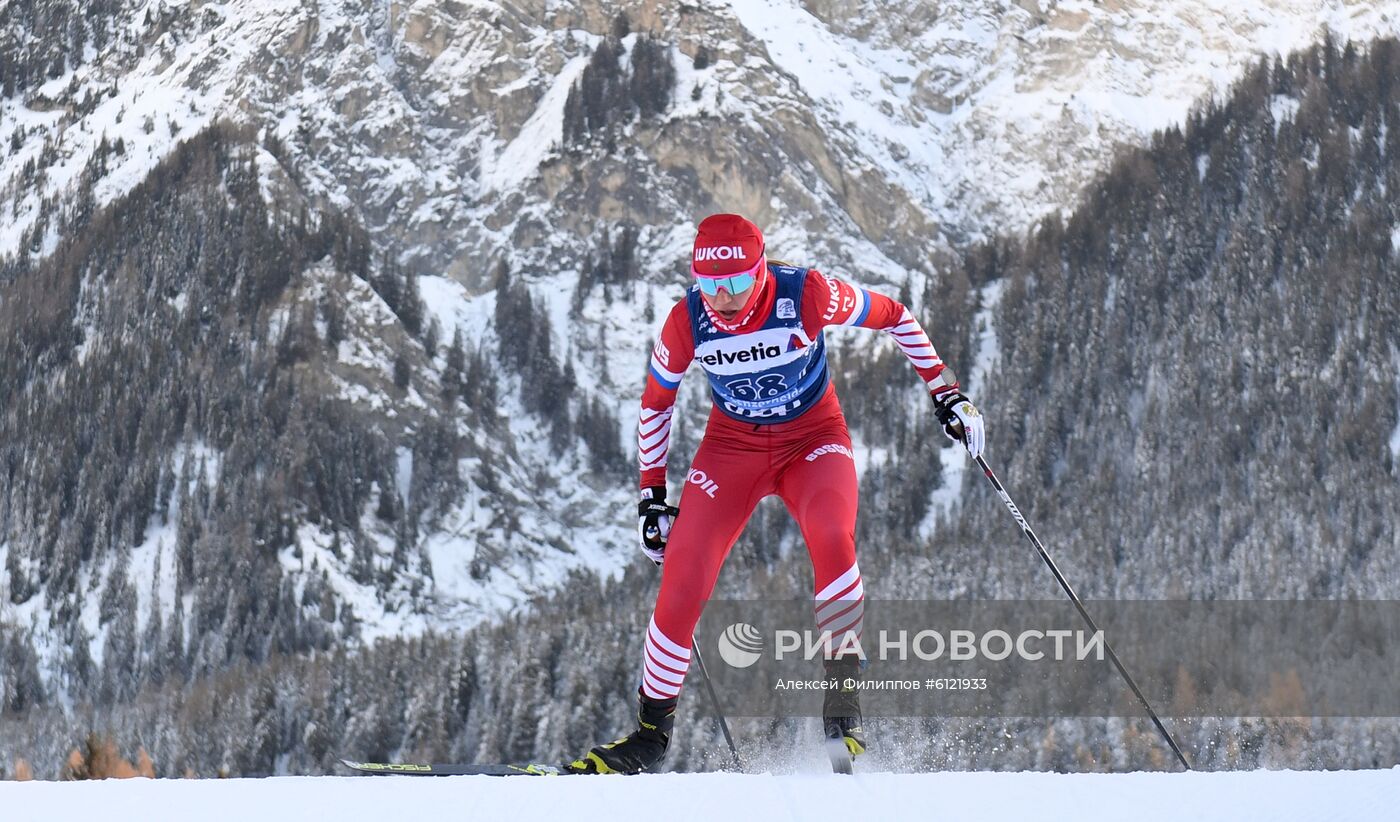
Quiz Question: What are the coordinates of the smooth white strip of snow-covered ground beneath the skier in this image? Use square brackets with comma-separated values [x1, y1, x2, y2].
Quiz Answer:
[0, 769, 1400, 822]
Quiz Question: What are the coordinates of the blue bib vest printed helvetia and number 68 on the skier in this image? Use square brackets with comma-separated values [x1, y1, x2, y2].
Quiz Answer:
[686, 263, 832, 424]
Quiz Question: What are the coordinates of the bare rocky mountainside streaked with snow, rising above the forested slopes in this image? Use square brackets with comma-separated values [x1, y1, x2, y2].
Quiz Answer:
[0, 0, 1400, 267]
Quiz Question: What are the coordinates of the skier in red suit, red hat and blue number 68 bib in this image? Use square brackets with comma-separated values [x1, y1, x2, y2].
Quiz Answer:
[567, 214, 984, 773]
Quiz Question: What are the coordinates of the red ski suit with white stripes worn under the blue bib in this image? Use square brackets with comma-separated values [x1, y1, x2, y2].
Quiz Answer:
[638, 269, 958, 699]
